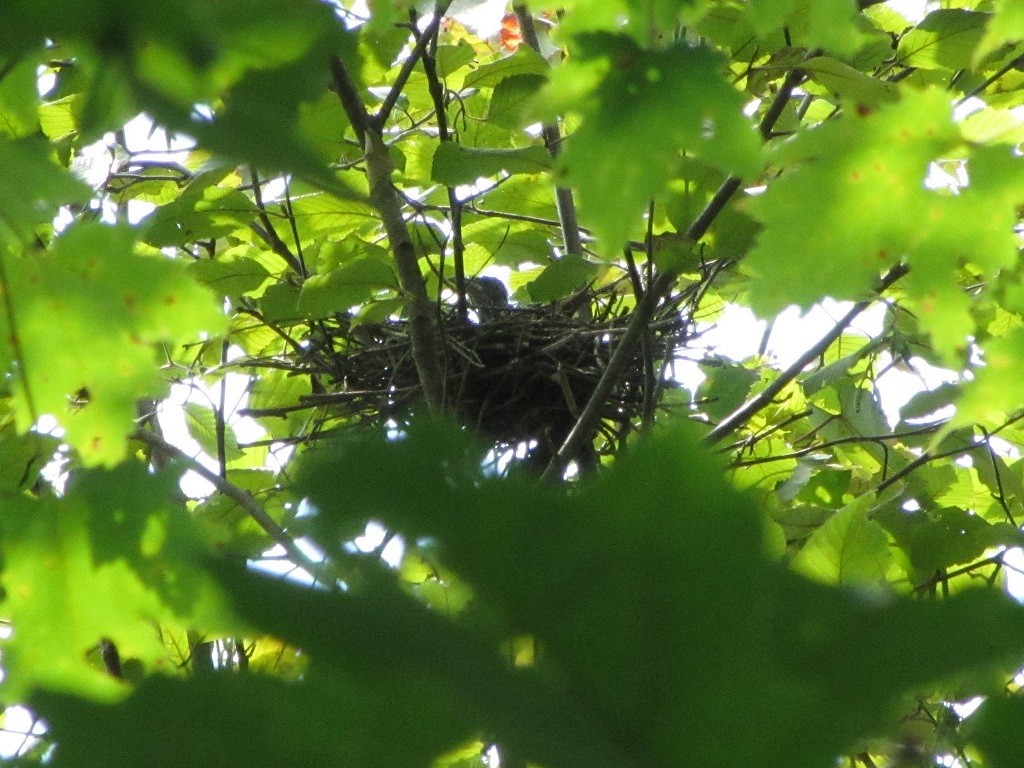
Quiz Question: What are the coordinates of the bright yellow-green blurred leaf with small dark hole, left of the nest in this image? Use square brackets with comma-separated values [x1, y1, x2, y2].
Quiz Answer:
[4, 223, 225, 465]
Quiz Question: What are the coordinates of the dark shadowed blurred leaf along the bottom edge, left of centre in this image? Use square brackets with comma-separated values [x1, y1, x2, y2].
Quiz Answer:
[32, 669, 471, 768]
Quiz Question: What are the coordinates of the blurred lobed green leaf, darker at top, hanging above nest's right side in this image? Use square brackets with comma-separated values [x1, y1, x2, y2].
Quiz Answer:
[542, 35, 760, 254]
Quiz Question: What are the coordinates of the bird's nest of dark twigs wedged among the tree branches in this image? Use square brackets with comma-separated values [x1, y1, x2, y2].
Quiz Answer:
[246, 286, 692, 469]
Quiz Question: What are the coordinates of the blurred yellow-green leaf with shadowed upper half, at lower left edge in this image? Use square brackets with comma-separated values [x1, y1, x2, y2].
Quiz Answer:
[0, 464, 213, 700]
